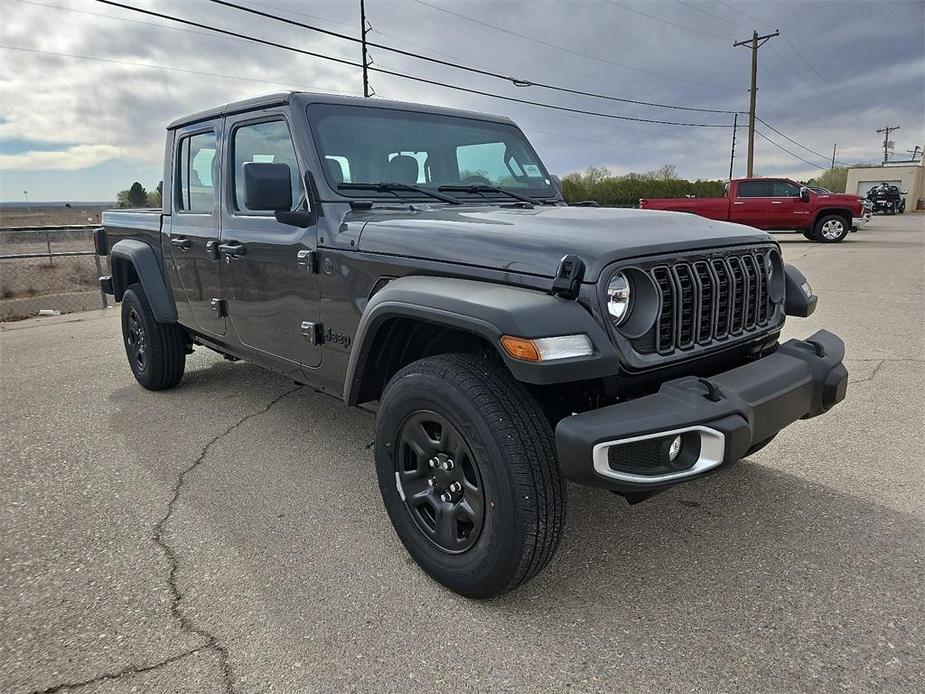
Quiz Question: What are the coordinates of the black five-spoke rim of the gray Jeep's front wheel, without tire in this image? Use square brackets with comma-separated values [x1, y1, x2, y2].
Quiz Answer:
[394, 410, 485, 554]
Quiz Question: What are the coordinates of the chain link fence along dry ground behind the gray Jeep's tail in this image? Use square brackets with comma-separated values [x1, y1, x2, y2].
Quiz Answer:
[0, 225, 108, 321]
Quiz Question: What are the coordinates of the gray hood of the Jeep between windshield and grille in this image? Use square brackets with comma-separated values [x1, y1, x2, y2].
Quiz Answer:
[357, 205, 771, 282]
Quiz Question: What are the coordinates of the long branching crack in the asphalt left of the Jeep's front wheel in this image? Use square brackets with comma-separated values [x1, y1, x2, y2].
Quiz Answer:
[33, 386, 301, 694]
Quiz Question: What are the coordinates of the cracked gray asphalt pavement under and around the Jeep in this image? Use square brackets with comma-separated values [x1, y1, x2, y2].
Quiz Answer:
[0, 214, 925, 694]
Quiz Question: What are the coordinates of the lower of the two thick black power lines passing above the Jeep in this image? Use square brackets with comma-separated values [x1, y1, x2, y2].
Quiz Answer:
[97, 0, 732, 128]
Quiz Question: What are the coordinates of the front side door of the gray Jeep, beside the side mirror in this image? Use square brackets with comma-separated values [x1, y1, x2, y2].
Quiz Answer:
[219, 109, 321, 367]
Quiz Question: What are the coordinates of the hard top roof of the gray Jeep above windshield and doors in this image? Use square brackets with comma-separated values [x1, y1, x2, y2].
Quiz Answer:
[167, 92, 513, 130]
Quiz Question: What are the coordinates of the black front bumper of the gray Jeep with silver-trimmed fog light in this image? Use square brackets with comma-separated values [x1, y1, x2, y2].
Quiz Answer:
[556, 330, 848, 493]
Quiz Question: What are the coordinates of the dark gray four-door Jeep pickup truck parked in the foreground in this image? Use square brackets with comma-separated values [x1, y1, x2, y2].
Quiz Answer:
[95, 93, 847, 598]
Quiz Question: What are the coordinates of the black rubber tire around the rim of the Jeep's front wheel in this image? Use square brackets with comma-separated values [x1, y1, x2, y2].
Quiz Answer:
[375, 354, 565, 598]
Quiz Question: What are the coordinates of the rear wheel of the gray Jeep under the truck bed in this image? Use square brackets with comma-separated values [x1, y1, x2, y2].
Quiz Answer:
[122, 282, 186, 390]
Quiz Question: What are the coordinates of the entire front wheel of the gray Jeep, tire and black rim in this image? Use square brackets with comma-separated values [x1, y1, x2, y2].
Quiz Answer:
[376, 354, 565, 598]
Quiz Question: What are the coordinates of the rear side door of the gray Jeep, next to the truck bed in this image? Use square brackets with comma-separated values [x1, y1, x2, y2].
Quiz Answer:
[165, 120, 225, 335]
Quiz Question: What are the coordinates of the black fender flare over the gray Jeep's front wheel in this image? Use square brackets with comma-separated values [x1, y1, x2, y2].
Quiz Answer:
[344, 276, 620, 404]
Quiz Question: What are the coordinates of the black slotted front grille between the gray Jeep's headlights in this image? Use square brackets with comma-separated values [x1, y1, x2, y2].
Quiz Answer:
[632, 249, 776, 355]
